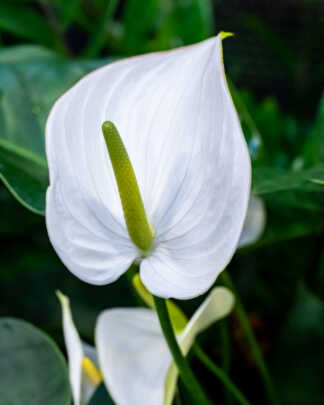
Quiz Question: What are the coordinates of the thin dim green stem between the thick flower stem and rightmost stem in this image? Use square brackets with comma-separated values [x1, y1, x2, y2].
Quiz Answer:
[193, 343, 251, 405]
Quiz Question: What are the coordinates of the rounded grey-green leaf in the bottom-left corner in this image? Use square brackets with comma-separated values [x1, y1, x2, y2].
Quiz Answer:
[0, 318, 71, 405]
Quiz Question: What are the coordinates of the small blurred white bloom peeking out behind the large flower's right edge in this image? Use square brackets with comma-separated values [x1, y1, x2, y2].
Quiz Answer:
[238, 194, 266, 247]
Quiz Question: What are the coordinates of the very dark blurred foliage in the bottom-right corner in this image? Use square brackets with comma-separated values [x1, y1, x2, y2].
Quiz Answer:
[273, 285, 324, 405]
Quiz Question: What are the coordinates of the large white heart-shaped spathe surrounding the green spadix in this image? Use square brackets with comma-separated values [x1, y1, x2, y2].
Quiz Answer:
[46, 34, 251, 299]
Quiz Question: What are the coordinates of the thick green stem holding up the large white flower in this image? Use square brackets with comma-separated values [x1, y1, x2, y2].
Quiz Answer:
[154, 296, 212, 405]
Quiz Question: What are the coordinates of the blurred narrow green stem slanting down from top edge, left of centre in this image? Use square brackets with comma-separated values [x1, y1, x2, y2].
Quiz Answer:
[82, 0, 118, 58]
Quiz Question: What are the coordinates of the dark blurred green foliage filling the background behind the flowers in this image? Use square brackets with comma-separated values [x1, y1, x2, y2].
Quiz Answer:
[0, 0, 324, 405]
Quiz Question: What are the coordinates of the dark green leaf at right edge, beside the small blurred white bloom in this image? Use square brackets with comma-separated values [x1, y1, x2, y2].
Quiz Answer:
[252, 165, 324, 247]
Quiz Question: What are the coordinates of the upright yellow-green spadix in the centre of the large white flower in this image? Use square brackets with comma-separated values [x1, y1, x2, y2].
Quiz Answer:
[102, 121, 153, 252]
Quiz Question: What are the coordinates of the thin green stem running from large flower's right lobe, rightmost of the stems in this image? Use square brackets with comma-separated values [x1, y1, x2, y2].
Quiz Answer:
[221, 271, 280, 405]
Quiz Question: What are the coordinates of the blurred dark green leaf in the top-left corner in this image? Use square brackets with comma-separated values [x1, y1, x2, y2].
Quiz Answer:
[0, 1, 54, 45]
